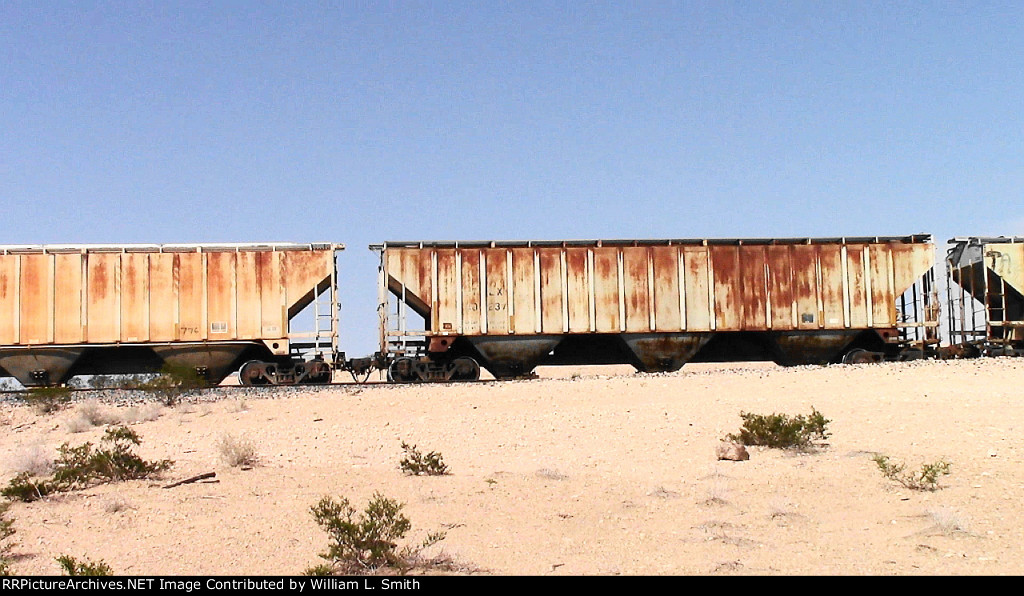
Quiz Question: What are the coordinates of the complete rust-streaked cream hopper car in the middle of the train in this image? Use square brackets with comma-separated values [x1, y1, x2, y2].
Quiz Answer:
[370, 235, 938, 381]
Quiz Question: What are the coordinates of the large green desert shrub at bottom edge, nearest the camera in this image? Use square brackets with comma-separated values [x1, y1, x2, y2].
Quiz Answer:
[305, 493, 444, 576]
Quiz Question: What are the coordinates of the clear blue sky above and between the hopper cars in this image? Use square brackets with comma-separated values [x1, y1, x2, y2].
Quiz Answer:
[0, 0, 1024, 355]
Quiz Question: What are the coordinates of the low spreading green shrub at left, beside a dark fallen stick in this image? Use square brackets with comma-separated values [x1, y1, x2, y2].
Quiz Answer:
[0, 426, 173, 501]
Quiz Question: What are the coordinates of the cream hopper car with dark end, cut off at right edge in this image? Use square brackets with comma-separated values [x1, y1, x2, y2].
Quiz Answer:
[946, 237, 1024, 355]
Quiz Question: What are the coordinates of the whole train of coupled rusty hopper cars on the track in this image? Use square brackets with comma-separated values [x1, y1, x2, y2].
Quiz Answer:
[0, 235, 1024, 387]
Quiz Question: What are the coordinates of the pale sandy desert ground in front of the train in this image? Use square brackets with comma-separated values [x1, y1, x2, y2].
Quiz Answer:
[0, 358, 1024, 576]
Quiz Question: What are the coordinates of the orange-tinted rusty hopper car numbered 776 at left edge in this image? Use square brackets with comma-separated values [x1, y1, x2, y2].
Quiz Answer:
[0, 243, 344, 386]
